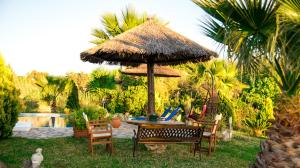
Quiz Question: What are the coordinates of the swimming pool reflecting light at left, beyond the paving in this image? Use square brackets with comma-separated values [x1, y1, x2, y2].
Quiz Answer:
[17, 113, 69, 128]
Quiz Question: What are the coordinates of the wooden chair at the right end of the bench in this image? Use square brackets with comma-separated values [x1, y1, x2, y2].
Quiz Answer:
[193, 114, 222, 155]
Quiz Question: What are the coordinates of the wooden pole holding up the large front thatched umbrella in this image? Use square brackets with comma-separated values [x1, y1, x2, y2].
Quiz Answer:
[147, 62, 155, 116]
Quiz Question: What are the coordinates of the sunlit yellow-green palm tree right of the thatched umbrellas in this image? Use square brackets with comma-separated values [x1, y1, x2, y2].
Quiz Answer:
[194, 60, 247, 120]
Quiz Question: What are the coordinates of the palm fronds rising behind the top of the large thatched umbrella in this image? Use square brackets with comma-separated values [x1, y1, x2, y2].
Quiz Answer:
[91, 6, 155, 45]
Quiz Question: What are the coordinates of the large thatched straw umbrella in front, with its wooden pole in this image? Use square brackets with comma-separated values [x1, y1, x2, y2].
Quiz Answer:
[80, 20, 217, 115]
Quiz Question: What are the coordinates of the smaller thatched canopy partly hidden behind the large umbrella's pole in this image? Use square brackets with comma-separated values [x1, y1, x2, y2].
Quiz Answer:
[121, 64, 180, 77]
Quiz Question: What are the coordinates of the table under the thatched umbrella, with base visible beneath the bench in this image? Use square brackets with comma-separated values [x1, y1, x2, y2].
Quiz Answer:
[126, 120, 185, 153]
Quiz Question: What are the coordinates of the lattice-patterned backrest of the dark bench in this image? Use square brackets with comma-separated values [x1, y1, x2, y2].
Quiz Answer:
[137, 125, 204, 142]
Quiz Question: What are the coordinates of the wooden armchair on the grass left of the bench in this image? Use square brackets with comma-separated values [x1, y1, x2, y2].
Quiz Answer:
[83, 113, 113, 155]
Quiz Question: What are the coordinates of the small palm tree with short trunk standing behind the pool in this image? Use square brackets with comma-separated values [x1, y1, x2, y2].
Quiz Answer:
[36, 76, 69, 112]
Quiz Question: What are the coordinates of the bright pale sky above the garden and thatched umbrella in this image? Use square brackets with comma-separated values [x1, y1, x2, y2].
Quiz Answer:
[0, 0, 218, 75]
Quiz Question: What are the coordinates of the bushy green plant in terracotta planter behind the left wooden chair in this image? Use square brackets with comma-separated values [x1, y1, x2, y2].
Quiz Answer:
[69, 106, 107, 138]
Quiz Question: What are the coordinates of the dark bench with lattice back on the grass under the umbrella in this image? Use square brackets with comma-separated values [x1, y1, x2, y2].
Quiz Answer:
[132, 125, 204, 157]
